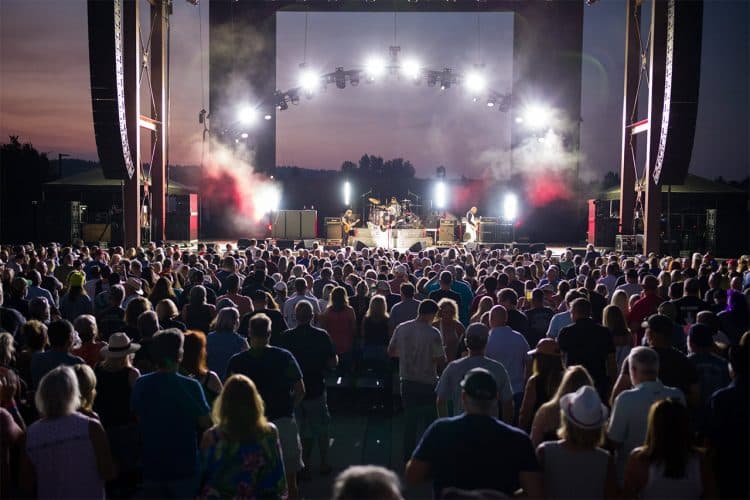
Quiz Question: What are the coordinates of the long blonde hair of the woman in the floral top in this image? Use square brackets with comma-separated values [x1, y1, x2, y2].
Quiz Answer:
[211, 374, 270, 440]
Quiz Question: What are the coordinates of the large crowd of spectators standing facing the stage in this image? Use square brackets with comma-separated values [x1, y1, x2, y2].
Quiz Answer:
[0, 240, 750, 499]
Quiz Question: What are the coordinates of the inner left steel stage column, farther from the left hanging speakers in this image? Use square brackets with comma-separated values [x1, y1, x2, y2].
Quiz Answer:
[151, 0, 169, 241]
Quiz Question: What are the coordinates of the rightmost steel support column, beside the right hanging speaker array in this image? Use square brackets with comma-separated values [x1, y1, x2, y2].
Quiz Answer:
[643, 0, 669, 254]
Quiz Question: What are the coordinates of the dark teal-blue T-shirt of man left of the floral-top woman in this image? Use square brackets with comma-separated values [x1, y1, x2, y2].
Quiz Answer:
[130, 371, 209, 481]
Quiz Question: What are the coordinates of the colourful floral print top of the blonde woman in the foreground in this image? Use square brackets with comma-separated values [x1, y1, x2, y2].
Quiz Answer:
[200, 427, 287, 499]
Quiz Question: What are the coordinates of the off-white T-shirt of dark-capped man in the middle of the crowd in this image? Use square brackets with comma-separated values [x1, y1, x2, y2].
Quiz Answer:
[388, 319, 445, 384]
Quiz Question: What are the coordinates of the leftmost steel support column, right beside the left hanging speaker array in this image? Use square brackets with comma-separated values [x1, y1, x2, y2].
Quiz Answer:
[122, 0, 141, 247]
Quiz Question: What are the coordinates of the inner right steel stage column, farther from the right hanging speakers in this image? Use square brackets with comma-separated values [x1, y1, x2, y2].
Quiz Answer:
[618, 0, 642, 234]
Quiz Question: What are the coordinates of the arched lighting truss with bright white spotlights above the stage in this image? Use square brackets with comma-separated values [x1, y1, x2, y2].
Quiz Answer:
[261, 46, 512, 116]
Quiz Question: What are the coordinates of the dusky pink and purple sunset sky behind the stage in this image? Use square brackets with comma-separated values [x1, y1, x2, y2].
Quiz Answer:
[0, 0, 750, 178]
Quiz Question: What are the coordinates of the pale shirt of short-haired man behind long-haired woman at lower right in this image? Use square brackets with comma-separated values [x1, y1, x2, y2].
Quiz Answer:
[607, 380, 685, 484]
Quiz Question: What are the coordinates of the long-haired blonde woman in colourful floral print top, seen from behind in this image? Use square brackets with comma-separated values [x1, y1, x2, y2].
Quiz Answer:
[199, 375, 287, 498]
